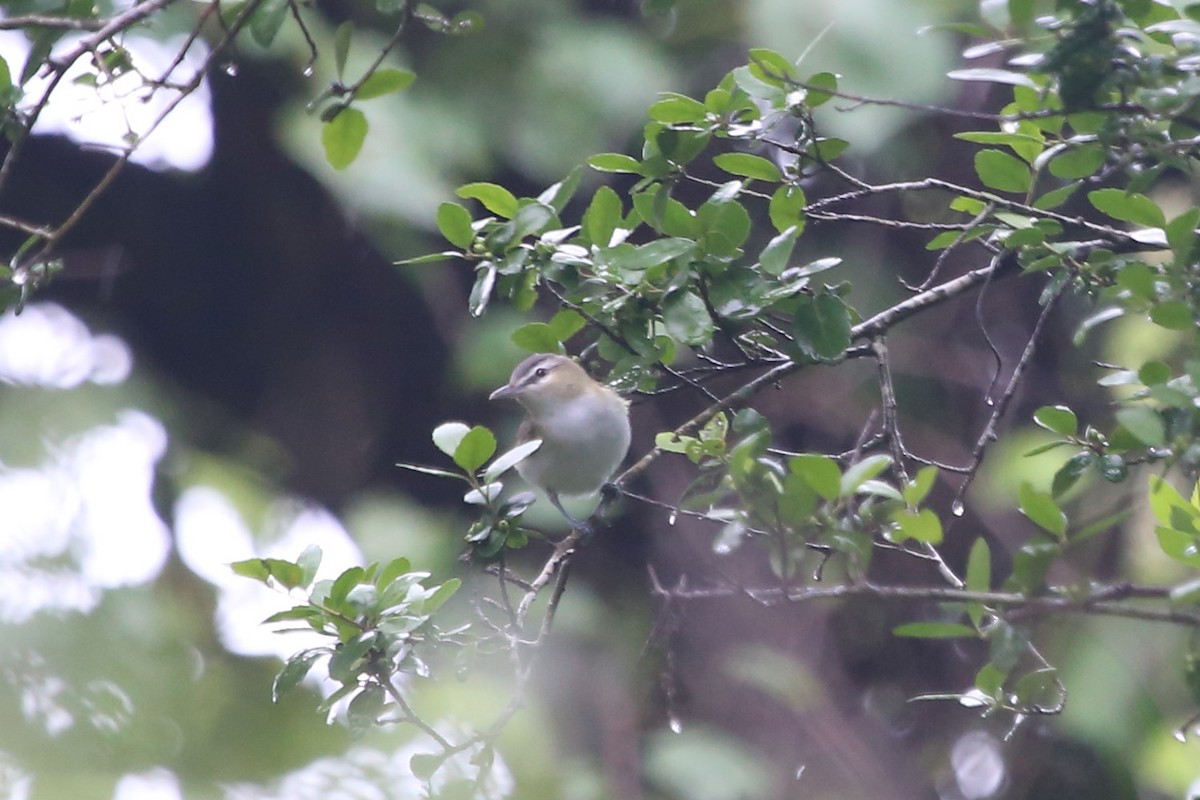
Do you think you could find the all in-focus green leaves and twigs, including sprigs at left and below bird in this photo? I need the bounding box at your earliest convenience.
[7,0,1200,795]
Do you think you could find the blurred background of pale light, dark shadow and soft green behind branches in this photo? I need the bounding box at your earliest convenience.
[0,0,1200,800]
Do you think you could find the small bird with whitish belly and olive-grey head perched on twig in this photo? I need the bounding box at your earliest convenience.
[488,353,629,533]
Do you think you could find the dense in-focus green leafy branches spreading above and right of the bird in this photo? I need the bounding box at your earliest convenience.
[386,1,1200,777]
